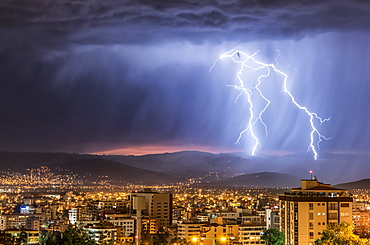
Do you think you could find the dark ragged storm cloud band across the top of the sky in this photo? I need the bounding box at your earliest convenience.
[0,0,370,52]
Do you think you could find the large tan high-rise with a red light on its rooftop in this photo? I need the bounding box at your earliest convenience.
[279,178,352,245]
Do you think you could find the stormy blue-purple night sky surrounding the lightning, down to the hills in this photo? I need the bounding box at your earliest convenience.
[0,0,370,155]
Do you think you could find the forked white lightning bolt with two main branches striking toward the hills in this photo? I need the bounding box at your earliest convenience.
[209,48,330,160]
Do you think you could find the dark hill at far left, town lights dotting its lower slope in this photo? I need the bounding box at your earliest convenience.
[0,152,179,184]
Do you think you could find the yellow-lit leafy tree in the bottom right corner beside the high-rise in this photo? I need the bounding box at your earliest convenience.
[315,222,370,245]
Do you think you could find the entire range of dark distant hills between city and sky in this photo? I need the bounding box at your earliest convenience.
[0,151,370,188]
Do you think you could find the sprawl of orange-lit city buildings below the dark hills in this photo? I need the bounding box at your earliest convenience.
[0,178,370,245]
